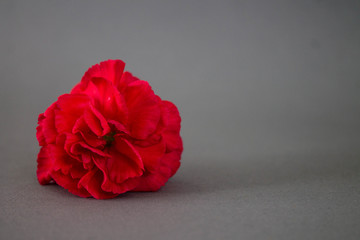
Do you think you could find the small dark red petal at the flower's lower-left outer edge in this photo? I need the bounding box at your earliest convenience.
[36,146,54,185]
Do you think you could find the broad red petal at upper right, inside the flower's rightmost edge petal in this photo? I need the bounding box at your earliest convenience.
[125,81,160,139]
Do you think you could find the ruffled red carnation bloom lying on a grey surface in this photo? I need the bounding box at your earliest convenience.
[36,60,183,199]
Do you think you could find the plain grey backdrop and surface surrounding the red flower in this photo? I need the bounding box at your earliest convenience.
[0,0,360,239]
